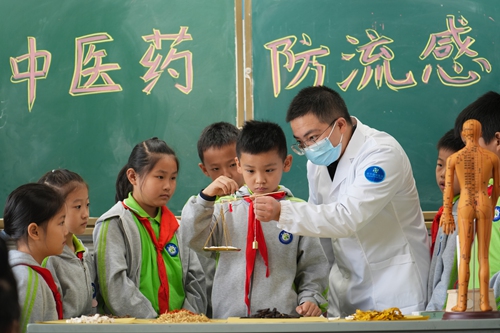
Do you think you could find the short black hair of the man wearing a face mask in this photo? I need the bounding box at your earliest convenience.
[286,86,352,124]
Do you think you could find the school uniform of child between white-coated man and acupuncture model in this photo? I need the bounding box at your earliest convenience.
[426,198,459,311]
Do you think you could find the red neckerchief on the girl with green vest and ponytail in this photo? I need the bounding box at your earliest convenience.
[122,202,179,314]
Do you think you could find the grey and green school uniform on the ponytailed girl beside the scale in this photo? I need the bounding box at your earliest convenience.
[93,195,207,318]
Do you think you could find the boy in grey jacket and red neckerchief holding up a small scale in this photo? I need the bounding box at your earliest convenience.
[181,121,328,318]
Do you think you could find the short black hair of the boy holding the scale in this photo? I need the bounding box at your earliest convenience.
[236,120,287,161]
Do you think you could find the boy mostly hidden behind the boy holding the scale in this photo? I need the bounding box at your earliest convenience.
[190,121,244,318]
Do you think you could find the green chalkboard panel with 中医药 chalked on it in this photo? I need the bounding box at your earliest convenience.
[0,0,236,216]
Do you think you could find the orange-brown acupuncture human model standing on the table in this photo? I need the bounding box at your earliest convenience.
[440,119,500,312]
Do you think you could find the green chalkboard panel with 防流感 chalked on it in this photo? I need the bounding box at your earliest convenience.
[251,0,500,210]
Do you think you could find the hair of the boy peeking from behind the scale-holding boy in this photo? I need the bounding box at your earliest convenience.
[197,121,240,163]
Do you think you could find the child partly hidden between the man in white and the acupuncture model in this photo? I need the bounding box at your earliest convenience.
[426,129,465,311]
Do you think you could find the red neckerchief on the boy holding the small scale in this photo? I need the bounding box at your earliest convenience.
[244,192,286,314]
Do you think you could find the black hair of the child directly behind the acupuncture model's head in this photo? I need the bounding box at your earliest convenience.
[455,91,500,144]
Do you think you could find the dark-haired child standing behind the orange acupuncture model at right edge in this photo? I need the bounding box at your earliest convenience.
[455,91,500,310]
